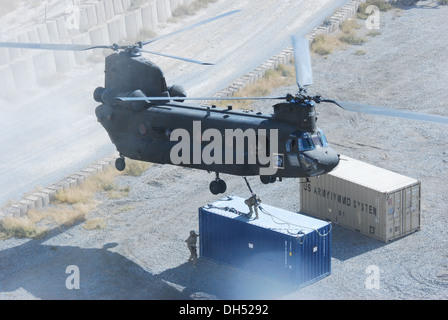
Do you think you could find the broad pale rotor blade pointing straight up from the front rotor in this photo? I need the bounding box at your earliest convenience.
[291,36,313,88]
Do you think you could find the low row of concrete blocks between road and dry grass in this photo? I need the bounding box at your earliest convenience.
[0,0,366,219]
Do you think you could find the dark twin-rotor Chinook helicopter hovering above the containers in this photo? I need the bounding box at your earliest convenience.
[0,11,448,194]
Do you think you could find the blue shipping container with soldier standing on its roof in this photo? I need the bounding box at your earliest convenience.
[199,196,331,287]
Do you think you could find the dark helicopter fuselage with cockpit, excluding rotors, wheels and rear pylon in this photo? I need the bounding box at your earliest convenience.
[96,98,339,179]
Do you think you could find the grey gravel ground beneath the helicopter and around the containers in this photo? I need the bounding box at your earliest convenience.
[0,1,448,299]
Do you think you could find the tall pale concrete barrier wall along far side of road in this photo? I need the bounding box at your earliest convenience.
[0,0,188,100]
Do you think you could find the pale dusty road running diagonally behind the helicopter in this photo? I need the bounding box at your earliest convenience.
[0,0,348,206]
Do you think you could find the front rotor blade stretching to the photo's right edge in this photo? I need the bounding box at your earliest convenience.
[321,100,448,124]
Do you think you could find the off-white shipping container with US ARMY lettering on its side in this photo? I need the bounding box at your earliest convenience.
[300,155,421,242]
